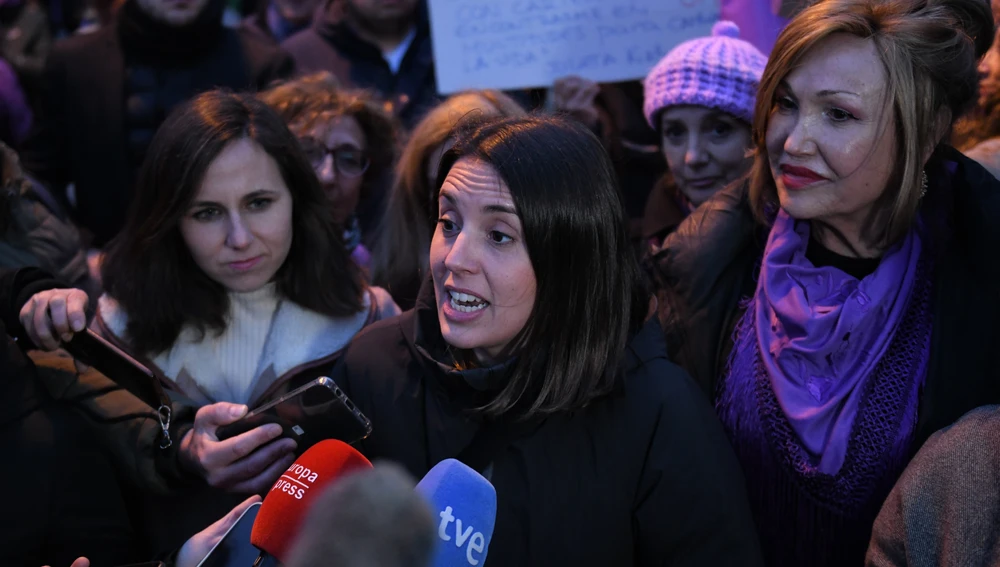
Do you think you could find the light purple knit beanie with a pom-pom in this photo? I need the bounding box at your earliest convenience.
[643,21,767,130]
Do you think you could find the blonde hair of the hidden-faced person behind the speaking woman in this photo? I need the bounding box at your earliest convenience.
[372,90,526,300]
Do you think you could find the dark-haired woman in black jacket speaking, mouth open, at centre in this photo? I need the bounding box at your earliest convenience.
[335,117,760,566]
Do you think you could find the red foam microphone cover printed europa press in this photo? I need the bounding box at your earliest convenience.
[250,439,372,563]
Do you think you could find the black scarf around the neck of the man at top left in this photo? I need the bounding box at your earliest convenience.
[117,0,226,66]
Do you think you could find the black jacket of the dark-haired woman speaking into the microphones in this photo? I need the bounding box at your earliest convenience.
[334,285,760,567]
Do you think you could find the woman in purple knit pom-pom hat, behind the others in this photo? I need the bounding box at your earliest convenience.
[643,21,767,246]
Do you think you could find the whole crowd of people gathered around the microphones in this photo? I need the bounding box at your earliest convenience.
[0,0,1000,567]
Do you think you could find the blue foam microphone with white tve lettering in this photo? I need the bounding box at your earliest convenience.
[416,459,497,567]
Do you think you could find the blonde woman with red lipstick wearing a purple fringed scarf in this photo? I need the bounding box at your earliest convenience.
[655,0,1000,567]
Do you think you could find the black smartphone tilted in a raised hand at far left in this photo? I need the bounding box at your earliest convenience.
[63,328,164,408]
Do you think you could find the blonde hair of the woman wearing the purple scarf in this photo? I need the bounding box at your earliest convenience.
[750,0,994,249]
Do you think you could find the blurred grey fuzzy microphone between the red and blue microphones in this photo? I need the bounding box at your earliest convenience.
[286,463,437,567]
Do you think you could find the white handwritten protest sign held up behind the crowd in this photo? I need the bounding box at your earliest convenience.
[430,0,719,94]
